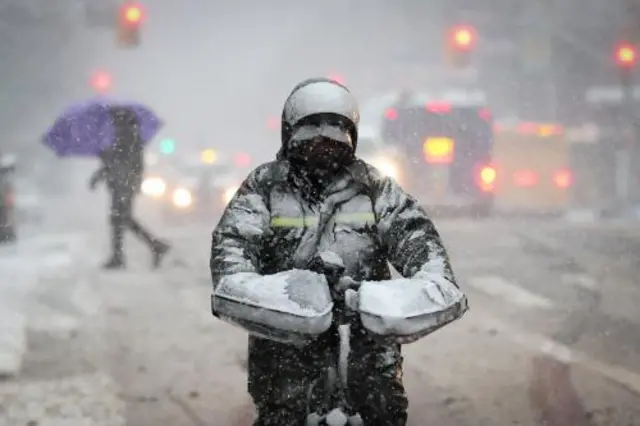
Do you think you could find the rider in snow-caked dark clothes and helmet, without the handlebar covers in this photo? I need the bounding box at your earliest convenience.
[210,79,455,426]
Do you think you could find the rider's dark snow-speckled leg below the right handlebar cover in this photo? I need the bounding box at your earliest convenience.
[349,345,409,426]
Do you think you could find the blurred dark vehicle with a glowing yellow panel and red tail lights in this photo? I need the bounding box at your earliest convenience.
[381,91,497,217]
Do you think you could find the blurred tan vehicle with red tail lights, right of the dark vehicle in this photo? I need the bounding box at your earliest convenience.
[493,121,573,214]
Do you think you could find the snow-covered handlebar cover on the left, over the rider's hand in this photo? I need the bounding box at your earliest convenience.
[211,269,333,344]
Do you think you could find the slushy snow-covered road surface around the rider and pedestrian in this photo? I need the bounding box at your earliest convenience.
[0,208,640,426]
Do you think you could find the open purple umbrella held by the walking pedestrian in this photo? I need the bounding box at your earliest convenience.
[43,98,163,157]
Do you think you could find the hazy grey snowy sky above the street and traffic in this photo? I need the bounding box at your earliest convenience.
[0,0,640,211]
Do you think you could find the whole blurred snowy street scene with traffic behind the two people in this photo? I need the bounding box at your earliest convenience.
[0,0,640,426]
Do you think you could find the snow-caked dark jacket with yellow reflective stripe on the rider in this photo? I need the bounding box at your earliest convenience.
[210,158,456,306]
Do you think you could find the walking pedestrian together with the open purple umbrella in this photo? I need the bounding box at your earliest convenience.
[44,99,170,269]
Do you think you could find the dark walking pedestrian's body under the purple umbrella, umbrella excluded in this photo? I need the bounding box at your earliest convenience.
[90,107,169,269]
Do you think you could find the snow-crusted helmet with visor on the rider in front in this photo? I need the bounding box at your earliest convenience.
[282,78,360,152]
